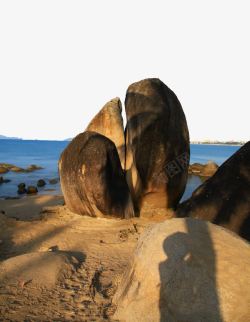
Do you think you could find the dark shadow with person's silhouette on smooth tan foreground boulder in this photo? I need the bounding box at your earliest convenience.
[159,218,223,322]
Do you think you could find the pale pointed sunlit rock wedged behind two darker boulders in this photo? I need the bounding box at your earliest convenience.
[86,97,125,168]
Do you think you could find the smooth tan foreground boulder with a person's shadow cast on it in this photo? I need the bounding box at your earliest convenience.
[113,218,250,322]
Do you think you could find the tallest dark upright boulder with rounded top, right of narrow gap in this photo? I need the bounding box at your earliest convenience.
[125,79,190,213]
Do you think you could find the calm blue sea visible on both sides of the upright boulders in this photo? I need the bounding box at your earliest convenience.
[0,140,239,200]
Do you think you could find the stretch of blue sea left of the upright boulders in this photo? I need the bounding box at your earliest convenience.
[0,140,69,198]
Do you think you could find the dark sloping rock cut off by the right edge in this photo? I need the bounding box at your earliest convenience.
[177,141,250,240]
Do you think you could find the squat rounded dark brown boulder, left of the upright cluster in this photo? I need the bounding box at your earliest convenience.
[59,131,134,218]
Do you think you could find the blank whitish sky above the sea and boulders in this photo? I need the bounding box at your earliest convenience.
[0,0,250,140]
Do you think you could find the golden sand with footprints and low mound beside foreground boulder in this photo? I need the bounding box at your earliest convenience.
[0,196,169,321]
